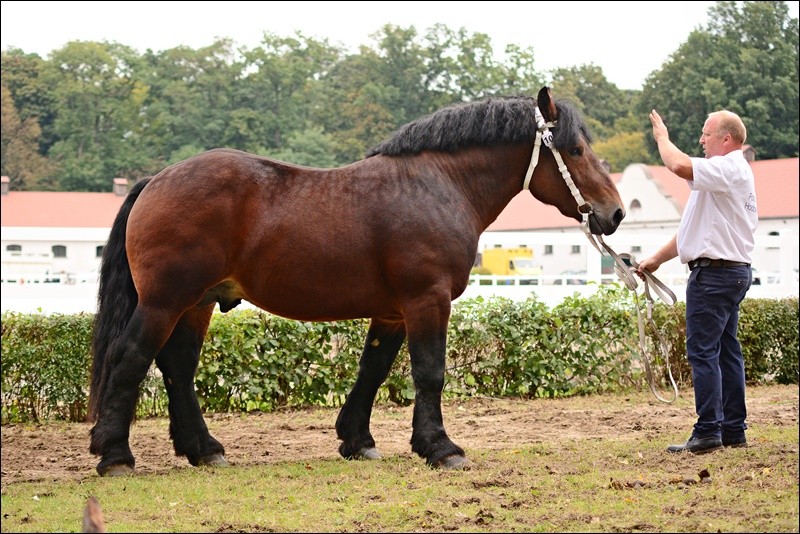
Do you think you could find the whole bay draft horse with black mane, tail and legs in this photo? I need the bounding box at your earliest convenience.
[89,87,625,475]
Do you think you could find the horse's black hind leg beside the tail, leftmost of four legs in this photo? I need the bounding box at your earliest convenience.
[89,304,178,475]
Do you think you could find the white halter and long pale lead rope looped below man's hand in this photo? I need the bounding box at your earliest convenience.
[523,107,678,403]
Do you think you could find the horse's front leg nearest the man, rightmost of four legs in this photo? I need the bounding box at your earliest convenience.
[405,297,468,469]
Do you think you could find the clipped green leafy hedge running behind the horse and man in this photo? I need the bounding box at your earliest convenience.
[2,284,798,422]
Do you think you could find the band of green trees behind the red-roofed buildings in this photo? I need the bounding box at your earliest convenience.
[0,1,800,191]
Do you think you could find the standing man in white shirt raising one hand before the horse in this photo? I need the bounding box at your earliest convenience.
[639,110,758,454]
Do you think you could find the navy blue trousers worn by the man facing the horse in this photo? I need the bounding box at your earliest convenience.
[686,265,753,438]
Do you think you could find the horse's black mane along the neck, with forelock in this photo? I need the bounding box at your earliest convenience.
[367,96,591,157]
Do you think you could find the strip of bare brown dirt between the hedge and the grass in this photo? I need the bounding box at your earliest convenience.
[1,385,798,488]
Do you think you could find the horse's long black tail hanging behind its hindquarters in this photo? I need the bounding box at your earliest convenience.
[89,178,150,421]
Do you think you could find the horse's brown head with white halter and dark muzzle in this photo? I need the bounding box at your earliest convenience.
[526,87,625,235]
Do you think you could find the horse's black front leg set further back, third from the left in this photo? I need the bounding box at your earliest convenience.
[336,319,406,458]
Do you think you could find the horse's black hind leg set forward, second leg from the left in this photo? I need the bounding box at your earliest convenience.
[156,304,228,466]
